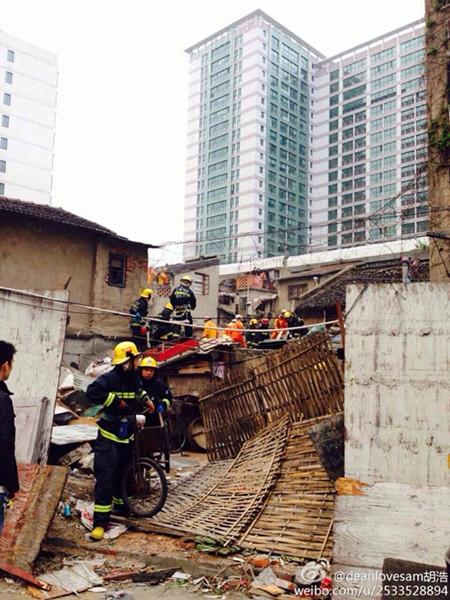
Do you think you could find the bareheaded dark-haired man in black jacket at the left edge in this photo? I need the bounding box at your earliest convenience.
[0,341,19,531]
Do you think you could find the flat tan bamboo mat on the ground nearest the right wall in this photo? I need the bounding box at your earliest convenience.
[237,418,334,559]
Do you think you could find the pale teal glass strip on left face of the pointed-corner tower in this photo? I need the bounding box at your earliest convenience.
[195,31,242,260]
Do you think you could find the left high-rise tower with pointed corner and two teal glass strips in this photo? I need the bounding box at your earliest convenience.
[184,10,323,262]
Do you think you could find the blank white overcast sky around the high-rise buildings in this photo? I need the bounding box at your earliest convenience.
[0,0,424,258]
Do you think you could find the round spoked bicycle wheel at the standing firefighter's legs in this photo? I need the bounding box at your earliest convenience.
[122,458,167,517]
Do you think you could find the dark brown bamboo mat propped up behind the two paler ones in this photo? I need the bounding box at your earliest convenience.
[200,333,344,461]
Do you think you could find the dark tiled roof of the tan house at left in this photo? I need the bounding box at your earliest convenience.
[0,196,155,246]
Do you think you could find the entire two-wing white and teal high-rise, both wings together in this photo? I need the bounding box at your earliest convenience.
[184,10,427,262]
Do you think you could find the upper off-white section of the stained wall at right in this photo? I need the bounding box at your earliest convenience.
[345,283,450,486]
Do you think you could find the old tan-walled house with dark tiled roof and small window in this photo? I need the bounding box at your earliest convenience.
[0,197,151,366]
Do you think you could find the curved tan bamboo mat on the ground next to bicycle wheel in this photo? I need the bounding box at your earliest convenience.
[152,418,288,545]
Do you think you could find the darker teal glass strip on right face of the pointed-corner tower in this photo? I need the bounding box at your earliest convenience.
[265,28,310,256]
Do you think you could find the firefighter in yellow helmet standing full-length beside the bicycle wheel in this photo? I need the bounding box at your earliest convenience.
[87,342,154,541]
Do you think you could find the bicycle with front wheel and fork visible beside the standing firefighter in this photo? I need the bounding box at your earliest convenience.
[121,410,168,517]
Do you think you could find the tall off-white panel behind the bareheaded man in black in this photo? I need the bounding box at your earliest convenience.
[0,287,69,464]
